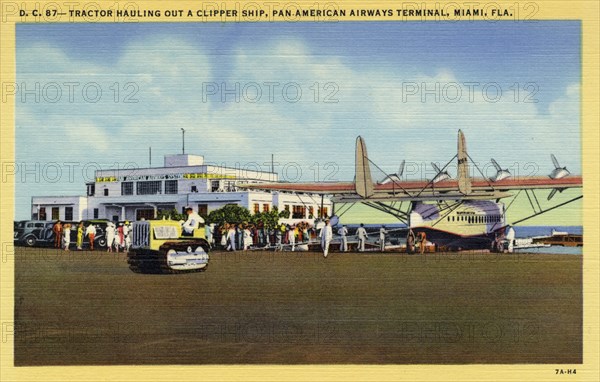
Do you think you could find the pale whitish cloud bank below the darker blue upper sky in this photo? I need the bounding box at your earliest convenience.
[17,37,581,218]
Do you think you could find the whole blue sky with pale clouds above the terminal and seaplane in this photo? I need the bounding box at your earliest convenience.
[16,21,581,218]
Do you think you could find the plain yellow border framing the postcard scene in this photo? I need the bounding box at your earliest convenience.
[0,0,600,381]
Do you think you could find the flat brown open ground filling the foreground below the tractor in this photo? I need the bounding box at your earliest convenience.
[14,248,582,366]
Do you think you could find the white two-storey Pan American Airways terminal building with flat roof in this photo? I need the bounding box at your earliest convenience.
[31,154,333,221]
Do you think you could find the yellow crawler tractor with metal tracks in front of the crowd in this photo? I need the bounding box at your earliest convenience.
[127,220,210,274]
